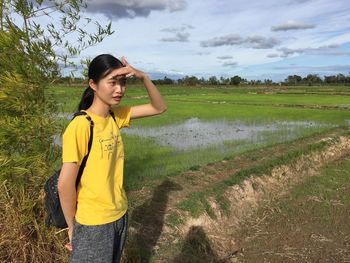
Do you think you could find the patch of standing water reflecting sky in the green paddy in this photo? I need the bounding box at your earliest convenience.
[123,118,334,150]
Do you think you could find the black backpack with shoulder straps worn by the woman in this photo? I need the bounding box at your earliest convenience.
[44,111,116,228]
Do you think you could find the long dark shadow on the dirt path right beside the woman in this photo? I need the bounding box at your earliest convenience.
[125,180,182,263]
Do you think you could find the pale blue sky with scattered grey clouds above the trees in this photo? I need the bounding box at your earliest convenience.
[66,0,350,81]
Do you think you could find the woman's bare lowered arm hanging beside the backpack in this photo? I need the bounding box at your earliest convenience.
[57,163,79,248]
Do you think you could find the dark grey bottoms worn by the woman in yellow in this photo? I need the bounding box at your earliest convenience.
[69,213,128,263]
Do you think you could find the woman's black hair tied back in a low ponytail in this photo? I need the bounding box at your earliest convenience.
[78,54,124,111]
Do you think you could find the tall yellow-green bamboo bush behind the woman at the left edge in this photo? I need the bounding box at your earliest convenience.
[0,0,111,262]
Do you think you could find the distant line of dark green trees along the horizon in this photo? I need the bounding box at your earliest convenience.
[56,74,350,86]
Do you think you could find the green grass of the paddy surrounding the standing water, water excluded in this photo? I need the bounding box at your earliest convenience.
[48,86,350,190]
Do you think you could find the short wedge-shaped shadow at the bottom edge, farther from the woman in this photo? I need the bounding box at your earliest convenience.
[173,226,225,263]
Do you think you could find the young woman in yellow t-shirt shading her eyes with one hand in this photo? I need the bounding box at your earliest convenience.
[58,54,166,263]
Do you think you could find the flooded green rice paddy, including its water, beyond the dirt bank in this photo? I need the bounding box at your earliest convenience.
[48,85,350,191]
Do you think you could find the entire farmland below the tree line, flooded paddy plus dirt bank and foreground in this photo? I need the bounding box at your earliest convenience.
[47,85,350,263]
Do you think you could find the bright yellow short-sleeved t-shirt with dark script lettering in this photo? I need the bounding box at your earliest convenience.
[62,106,131,225]
